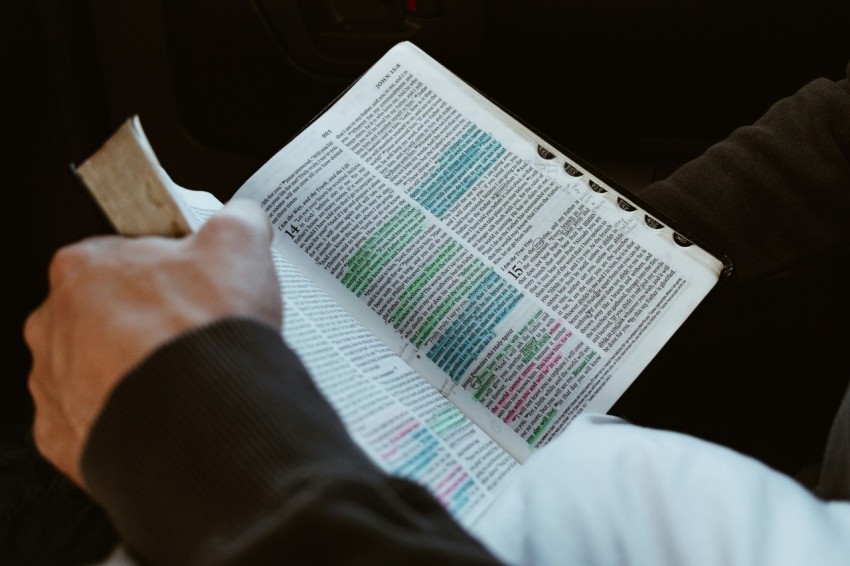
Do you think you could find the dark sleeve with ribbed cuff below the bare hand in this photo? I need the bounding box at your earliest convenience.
[82,320,495,565]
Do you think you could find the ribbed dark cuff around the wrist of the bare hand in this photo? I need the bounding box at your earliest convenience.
[82,319,381,564]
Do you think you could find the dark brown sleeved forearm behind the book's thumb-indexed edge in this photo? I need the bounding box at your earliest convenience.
[642,63,850,282]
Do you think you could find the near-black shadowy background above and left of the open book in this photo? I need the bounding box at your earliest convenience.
[6,0,850,564]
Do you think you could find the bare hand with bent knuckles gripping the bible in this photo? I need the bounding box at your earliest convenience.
[24,201,282,486]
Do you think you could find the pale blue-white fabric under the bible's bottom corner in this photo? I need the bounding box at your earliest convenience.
[473,415,850,566]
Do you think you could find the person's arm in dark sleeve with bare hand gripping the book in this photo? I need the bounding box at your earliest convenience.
[25,204,495,564]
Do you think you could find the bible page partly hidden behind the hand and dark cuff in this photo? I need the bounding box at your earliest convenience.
[179,189,518,527]
